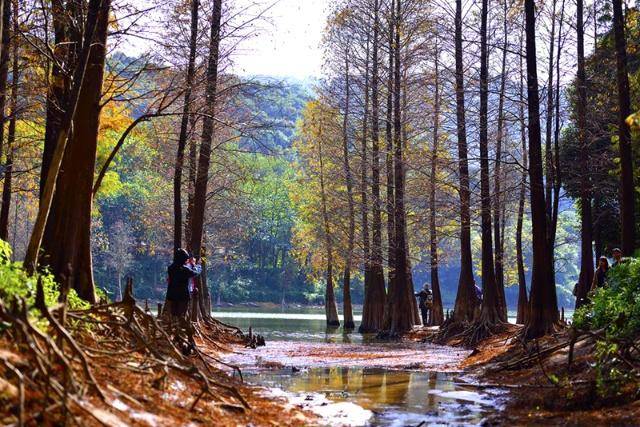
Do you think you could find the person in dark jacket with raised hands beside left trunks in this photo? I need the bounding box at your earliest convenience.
[167,249,202,318]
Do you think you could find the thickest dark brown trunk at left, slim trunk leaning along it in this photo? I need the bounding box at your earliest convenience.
[25,0,110,302]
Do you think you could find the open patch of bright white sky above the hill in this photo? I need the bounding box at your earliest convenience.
[234,0,331,79]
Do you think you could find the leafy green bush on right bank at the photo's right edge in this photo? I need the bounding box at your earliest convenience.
[573,258,640,396]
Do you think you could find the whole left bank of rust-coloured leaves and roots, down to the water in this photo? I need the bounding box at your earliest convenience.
[0,290,315,427]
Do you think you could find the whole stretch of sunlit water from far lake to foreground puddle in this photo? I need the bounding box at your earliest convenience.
[214,308,503,426]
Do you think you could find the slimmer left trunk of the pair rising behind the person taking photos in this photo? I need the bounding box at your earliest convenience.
[173,0,200,251]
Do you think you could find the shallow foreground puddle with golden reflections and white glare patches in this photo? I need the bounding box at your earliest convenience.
[244,367,502,426]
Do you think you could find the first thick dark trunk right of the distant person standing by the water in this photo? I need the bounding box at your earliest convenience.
[453,0,479,322]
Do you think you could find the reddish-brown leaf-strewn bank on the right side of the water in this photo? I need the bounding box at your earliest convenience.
[410,325,640,426]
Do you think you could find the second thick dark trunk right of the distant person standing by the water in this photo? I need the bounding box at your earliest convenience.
[480,0,502,323]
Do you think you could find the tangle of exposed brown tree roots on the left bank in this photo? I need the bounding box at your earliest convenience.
[0,280,276,425]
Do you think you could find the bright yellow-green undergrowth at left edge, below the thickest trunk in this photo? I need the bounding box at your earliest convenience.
[0,240,89,328]
